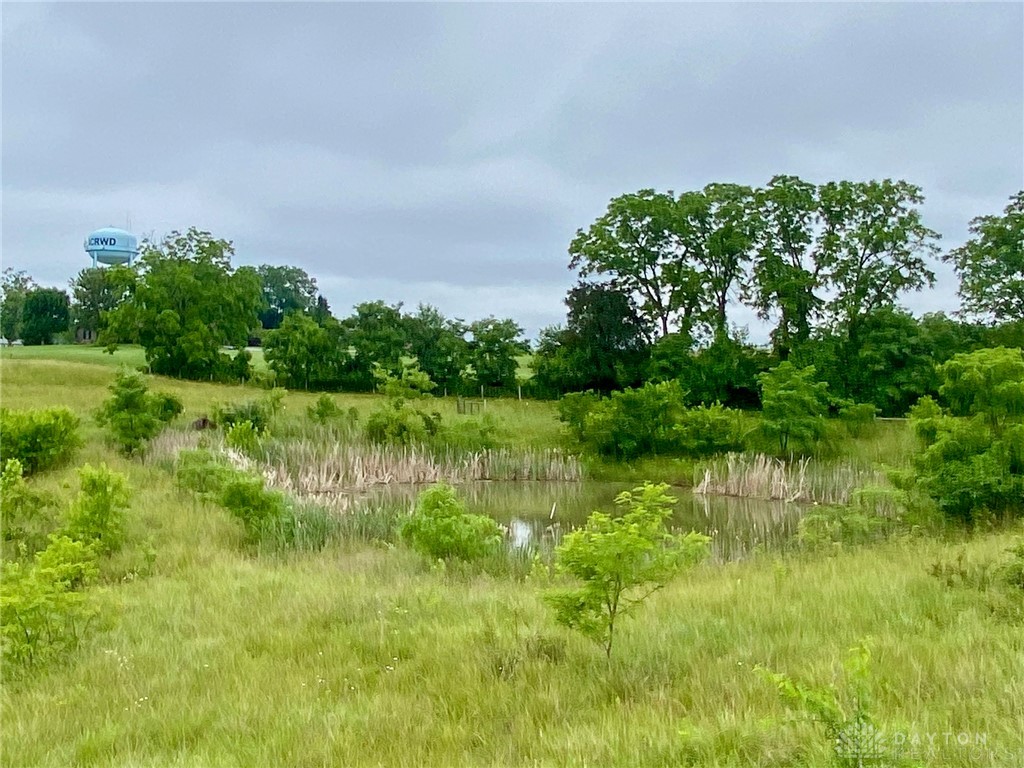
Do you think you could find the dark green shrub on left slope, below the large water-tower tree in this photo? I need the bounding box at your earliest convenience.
[96,369,182,456]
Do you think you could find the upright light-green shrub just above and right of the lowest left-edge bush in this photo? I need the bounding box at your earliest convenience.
[66,464,131,552]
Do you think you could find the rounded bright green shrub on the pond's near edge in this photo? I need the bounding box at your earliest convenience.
[400,483,502,561]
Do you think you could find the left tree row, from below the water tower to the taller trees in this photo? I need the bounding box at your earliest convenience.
[0,228,529,393]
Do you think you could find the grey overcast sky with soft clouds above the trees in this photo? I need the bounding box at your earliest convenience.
[2,2,1024,339]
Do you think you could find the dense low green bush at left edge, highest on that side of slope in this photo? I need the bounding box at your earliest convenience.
[0,408,82,475]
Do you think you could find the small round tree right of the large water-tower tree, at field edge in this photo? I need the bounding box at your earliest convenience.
[263,313,350,390]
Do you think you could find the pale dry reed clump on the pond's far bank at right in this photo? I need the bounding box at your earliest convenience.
[693,454,886,505]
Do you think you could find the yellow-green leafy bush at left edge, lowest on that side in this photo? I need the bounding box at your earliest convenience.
[0,536,98,677]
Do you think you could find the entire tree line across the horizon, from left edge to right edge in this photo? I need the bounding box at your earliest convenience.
[0,182,1024,415]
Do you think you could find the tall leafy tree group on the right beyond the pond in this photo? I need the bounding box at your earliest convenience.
[534,176,1024,416]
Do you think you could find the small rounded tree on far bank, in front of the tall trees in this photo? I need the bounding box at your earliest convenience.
[758,360,828,456]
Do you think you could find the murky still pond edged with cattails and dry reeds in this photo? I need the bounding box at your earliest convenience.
[362,480,805,562]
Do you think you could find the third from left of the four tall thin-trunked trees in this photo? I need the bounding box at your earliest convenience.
[748,176,823,360]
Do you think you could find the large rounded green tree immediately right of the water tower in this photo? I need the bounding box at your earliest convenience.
[100,227,261,379]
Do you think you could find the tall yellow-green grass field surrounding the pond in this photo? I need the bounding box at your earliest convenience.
[0,358,1024,768]
